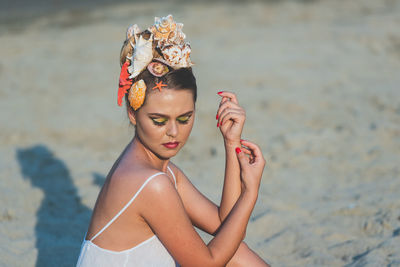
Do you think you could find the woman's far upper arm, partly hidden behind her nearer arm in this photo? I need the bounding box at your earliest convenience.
[173,166,221,234]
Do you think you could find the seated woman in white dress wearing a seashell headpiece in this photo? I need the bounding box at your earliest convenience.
[77,15,268,266]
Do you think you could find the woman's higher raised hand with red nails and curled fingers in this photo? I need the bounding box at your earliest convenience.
[217,91,246,147]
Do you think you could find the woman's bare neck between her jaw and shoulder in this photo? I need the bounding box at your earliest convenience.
[129,136,169,172]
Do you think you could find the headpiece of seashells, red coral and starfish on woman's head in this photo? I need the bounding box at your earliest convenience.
[118,15,193,110]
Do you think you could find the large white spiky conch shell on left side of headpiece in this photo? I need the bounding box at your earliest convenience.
[127,34,153,79]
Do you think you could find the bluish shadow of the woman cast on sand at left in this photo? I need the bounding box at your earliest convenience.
[16,145,93,267]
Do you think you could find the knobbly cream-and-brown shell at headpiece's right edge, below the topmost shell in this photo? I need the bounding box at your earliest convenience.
[161,43,193,68]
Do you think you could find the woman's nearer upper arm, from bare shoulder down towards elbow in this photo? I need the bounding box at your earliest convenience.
[141,175,216,266]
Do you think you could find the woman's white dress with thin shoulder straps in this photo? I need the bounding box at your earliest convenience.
[76,167,179,267]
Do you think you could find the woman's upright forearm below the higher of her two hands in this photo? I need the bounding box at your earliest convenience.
[219,140,241,222]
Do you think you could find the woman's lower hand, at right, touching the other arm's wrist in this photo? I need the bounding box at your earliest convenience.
[236,140,265,195]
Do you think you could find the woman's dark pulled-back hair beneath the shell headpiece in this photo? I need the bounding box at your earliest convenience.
[125,68,197,112]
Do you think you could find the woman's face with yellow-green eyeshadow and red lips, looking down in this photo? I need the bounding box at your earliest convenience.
[130,89,195,159]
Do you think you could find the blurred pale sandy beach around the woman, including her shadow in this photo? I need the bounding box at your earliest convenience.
[0,0,400,266]
